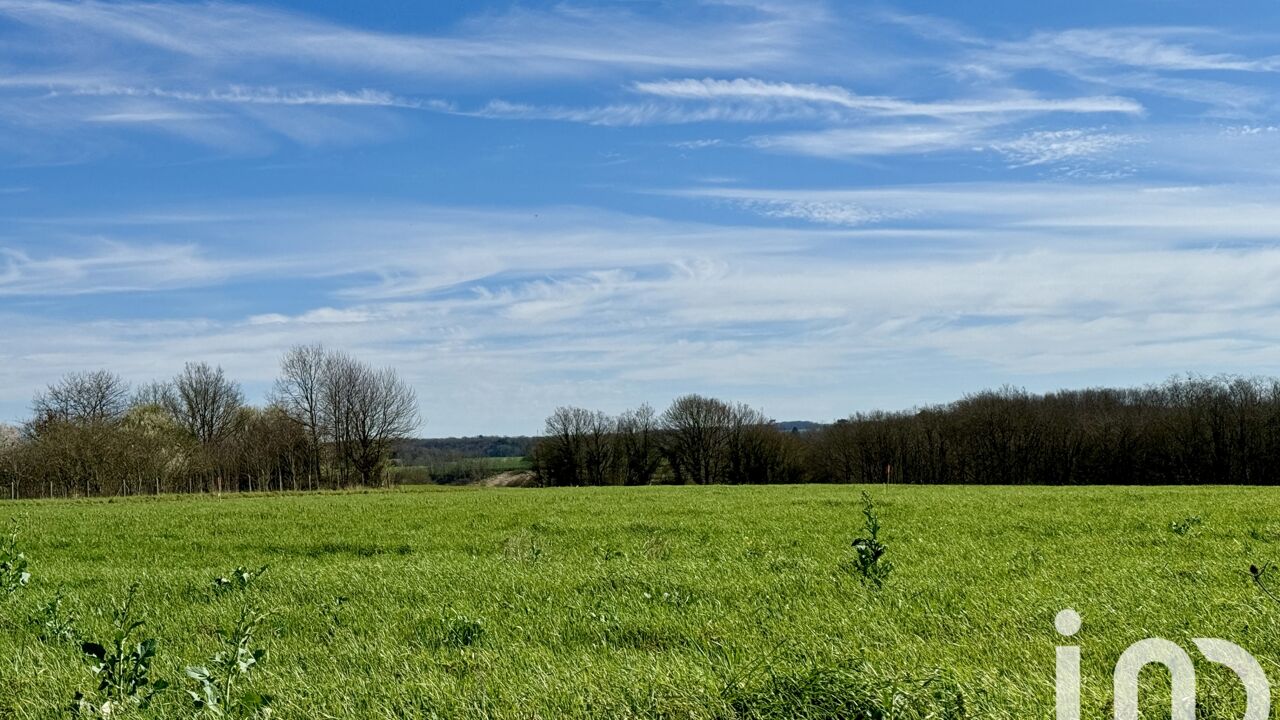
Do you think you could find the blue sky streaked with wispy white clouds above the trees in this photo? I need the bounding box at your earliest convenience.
[0,0,1280,437]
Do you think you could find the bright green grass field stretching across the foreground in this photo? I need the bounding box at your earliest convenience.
[0,486,1280,719]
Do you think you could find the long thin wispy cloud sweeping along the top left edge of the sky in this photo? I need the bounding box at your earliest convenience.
[0,0,823,78]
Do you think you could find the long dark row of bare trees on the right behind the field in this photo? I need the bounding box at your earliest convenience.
[532,377,1280,486]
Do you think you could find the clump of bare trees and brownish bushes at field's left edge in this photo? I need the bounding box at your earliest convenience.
[0,345,419,498]
